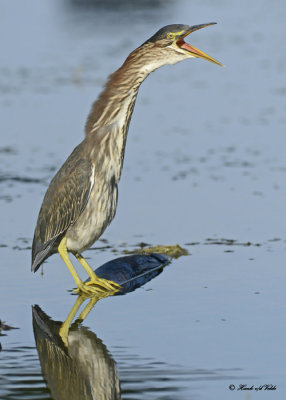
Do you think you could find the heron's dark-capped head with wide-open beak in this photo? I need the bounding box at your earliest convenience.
[131,22,222,72]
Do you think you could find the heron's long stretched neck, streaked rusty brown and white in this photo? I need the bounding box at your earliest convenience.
[86,50,157,182]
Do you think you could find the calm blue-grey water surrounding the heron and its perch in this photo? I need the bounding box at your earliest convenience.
[0,0,286,400]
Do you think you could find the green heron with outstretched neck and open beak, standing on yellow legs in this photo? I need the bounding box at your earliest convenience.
[32,22,222,294]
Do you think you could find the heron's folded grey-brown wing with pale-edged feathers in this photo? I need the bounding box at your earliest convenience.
[32,148,93,271]
